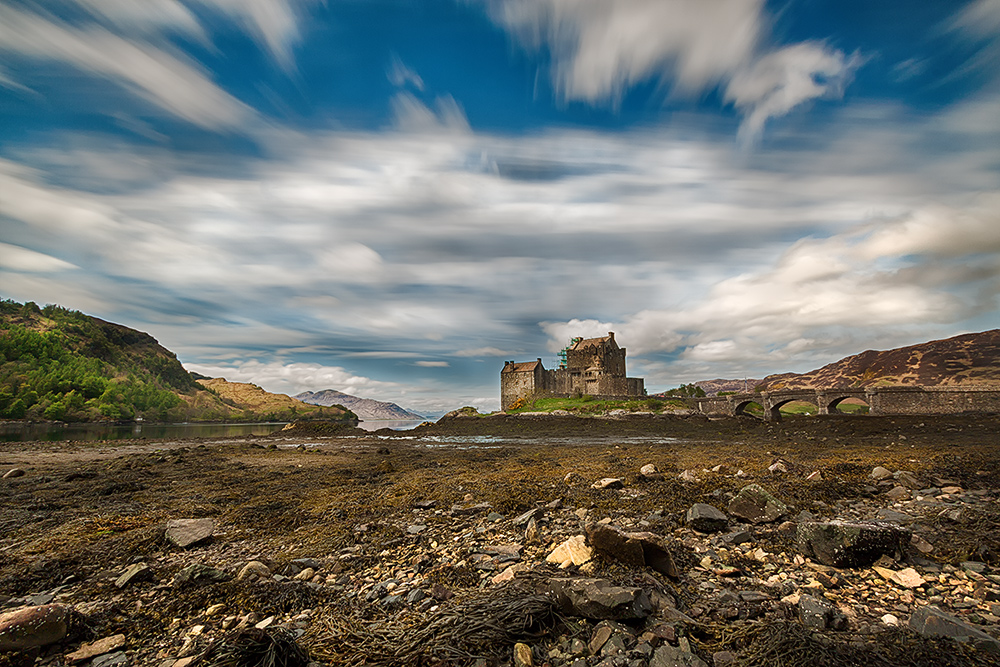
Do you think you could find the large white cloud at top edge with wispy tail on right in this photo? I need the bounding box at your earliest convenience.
[480,0,860,141]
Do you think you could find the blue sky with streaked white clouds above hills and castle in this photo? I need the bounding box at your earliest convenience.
[0,0,1000,414]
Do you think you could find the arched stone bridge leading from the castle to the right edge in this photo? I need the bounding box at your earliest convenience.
[693,387,1000,421]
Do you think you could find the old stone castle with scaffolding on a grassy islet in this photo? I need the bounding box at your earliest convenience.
[500,332,646,410]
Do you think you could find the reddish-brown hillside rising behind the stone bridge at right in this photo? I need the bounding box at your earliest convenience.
[758,329,1000,391]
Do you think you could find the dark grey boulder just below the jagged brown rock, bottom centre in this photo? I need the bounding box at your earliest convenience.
[548,579,653,621]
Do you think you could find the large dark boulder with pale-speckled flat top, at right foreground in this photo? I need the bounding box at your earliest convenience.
[796,521,910,567]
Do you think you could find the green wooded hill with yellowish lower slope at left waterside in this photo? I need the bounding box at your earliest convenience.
[0,300,354,421]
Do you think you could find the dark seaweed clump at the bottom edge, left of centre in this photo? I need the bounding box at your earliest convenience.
[194,628,309,667]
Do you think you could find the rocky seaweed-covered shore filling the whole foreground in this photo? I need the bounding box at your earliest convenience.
[0,416,1000,667]
